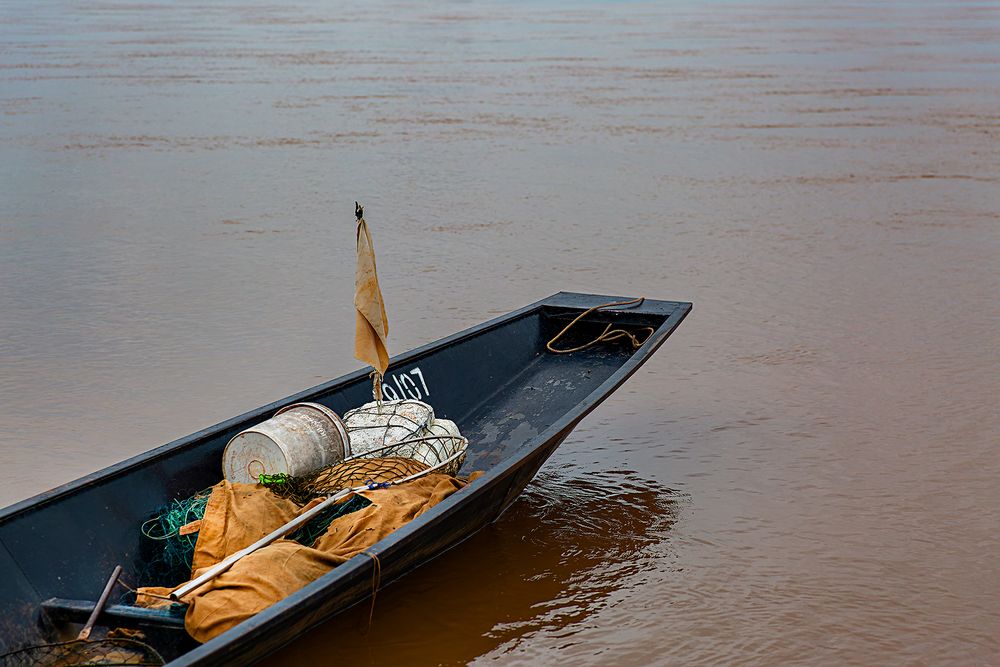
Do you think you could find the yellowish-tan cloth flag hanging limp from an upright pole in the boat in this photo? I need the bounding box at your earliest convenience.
[354,202,389,376]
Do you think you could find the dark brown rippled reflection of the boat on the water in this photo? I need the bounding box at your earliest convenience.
[269,465,684,665]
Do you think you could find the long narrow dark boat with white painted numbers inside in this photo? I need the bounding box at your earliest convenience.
[0,293,691,665]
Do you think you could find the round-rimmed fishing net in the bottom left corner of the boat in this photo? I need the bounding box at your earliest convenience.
[0,637,164,667]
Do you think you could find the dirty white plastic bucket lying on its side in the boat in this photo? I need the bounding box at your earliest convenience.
[222,403,348,483]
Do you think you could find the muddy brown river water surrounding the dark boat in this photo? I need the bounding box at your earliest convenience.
[0,0,1000,665]
